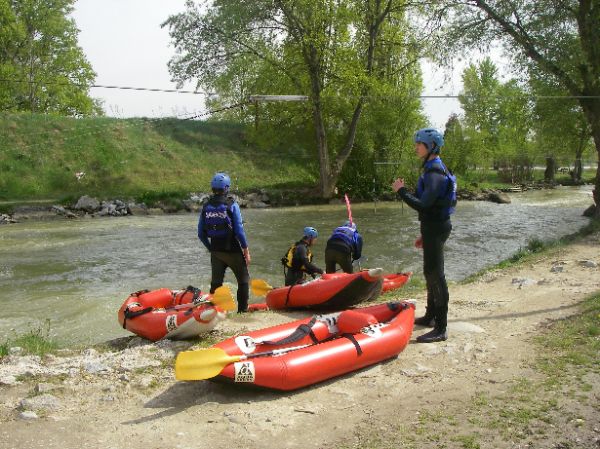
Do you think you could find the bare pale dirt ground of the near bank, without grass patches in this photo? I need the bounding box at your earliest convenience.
[0,234,600,449]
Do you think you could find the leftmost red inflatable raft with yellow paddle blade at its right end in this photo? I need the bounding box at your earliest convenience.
[118,287,235,341]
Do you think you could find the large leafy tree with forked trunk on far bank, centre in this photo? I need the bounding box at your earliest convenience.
[164,0,421,198]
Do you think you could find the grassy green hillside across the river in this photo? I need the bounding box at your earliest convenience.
[0,114,317,201]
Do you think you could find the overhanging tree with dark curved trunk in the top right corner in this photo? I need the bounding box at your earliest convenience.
[443,0,600,217]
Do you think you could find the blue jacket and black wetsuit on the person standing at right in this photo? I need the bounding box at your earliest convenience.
[398,157,452,333]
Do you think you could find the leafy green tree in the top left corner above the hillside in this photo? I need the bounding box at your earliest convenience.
[0,0,102,116]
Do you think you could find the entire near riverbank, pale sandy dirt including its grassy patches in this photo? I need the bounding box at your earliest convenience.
[0,230,600,449]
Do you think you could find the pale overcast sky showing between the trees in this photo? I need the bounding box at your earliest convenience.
[73,0,486,128]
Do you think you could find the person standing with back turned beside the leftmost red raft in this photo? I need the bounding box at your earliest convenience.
[198,173,250,313]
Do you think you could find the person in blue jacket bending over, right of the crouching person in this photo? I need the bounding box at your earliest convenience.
[325,221,362,273]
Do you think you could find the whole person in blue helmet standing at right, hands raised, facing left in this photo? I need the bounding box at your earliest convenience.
[392,128,456,343]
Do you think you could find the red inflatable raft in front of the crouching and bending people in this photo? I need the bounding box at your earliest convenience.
[266,268,383,310]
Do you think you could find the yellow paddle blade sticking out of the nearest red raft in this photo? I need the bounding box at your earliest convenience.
[175,348,244,380]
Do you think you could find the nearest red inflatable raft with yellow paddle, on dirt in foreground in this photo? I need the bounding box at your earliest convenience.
[175,302,415,390]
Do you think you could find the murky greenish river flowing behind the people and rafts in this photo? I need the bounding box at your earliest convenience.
[0,187,592,344]
